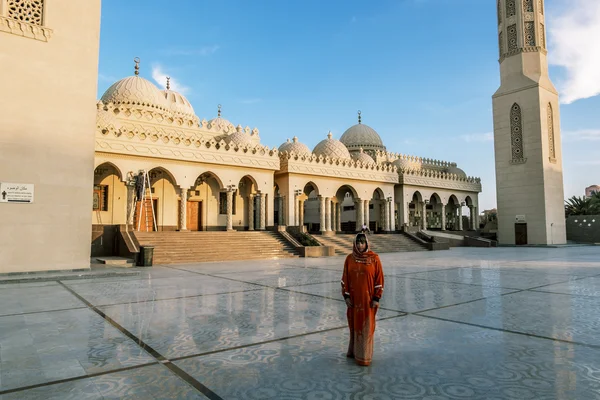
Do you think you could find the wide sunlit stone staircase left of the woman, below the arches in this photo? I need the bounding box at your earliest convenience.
[134,231,298,265]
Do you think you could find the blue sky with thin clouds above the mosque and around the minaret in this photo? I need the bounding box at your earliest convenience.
[98,0,600,210]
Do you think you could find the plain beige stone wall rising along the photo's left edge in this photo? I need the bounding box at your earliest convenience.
[0,0,100,273]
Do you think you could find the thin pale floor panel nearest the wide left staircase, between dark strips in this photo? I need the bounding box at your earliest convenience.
[65,274,261,305]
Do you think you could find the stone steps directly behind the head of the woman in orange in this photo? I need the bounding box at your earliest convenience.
[315,233,427,255]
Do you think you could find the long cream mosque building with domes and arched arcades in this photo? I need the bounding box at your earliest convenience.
[92,59,481,235]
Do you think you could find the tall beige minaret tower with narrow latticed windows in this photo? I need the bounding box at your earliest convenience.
[493,0,566,245]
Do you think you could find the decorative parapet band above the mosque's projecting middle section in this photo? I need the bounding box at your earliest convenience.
[279,151,398,183]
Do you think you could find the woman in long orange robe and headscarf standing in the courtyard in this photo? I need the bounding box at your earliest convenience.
[342,233,383,366]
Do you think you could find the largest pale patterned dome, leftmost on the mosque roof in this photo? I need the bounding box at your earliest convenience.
[102,75,168,110]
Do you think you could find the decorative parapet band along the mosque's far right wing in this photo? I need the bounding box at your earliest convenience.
[398,169,481,193]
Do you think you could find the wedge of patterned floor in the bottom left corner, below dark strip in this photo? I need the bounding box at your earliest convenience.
[1,365,206,400]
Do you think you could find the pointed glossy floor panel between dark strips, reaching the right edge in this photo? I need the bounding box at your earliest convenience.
[423,292,600,346]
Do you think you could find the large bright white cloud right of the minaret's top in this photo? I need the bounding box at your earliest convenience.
[547,0,600,104]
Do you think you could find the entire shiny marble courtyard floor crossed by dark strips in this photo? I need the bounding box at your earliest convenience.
[0,247,600,400]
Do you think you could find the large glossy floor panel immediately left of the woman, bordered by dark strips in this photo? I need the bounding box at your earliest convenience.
[101,289,398,358]
